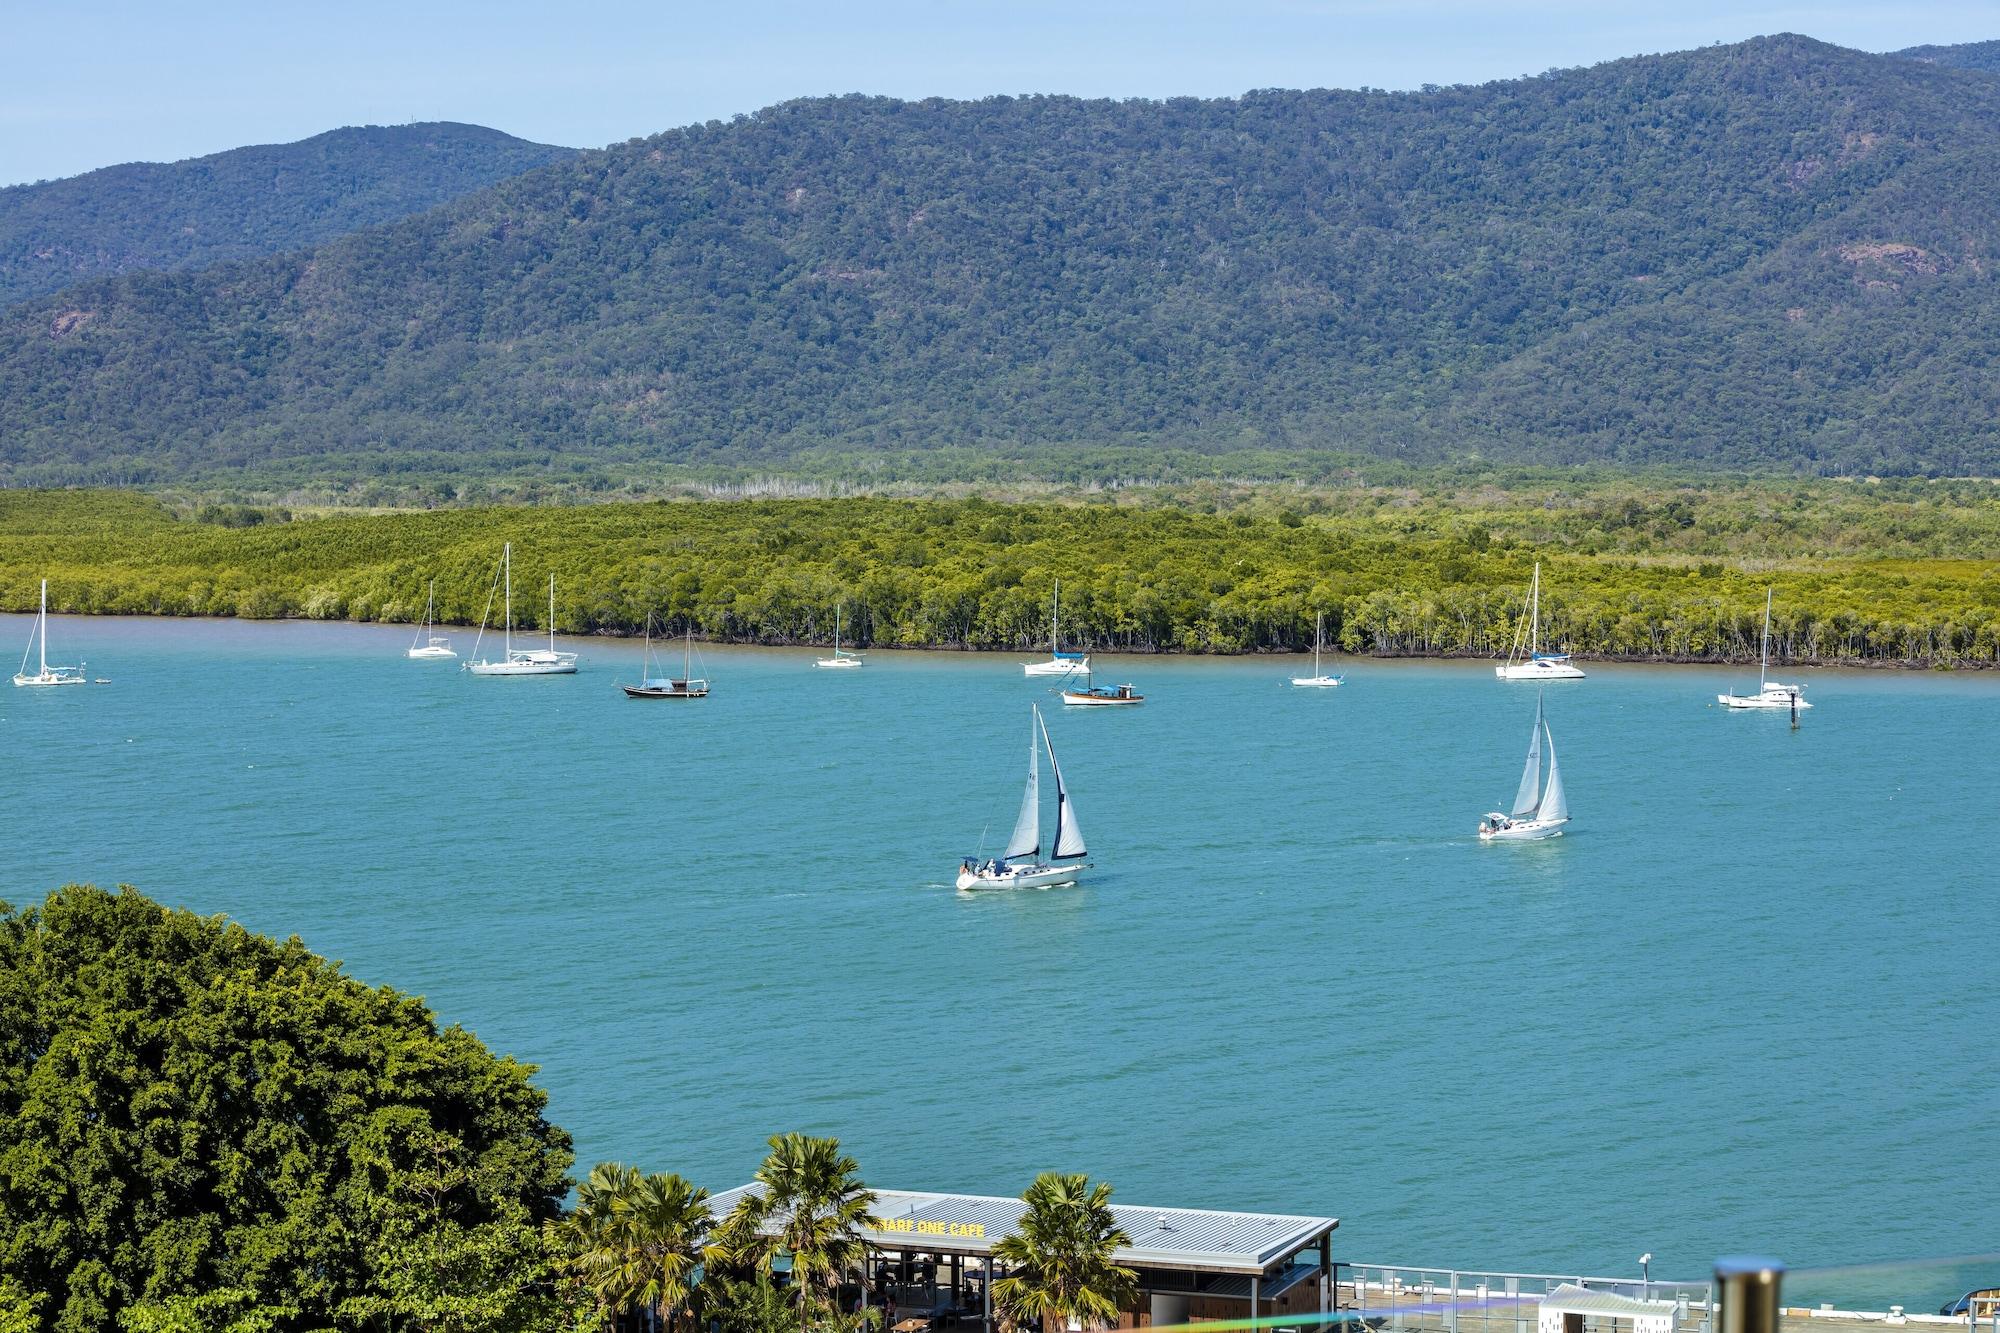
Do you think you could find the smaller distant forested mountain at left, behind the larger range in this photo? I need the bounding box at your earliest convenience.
[0,122,574,306]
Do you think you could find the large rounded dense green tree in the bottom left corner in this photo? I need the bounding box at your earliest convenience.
[0,887,572,1333]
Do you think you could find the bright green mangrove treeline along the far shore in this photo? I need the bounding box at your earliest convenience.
[0,482,2000,667]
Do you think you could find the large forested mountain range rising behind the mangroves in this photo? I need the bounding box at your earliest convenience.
[11,36,2000,484]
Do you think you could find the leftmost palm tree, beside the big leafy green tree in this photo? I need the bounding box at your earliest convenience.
[560,1163,714,1329]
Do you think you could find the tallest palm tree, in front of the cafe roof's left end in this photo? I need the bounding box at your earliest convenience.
[722,1135,880,1327]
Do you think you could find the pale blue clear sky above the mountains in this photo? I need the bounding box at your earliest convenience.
[11,0,2000,184]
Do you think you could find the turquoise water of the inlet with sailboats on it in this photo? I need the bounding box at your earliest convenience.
[0,618,2000,1307]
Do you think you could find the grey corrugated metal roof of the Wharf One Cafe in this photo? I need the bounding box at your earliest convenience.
[710,1185,1340,1273]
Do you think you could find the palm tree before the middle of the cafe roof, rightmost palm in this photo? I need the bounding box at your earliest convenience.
[994,1171,1138,1333]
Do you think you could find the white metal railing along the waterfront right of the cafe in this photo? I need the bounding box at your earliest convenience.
[1334,1263,1714,1333]
